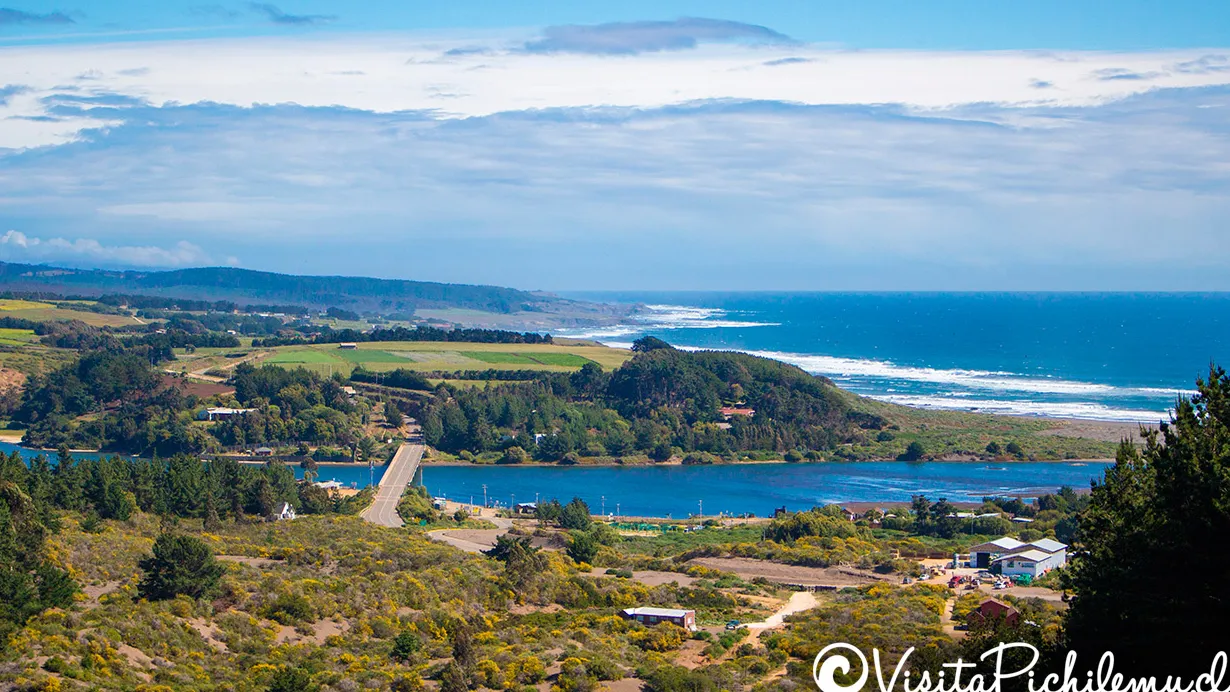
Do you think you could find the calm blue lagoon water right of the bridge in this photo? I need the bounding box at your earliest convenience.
[423,461,1108,517]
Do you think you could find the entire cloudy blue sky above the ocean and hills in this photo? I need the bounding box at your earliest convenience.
[0,0,1230,291]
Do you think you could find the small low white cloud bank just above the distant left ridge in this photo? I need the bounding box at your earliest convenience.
[0,230,216,267]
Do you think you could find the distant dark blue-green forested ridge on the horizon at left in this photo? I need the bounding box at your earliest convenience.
[0,262,615,313]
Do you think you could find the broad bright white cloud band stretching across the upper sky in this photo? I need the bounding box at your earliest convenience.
[0,33,1230,146]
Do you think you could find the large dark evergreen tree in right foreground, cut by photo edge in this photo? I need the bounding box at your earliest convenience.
[1065,366,1230,680]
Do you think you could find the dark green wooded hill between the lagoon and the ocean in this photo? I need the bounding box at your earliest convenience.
[417,348,884,461]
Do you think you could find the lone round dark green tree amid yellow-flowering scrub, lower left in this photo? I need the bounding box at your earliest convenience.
[138,533,226,601]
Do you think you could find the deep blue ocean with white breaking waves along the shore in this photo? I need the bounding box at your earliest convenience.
[557,293,1230,422]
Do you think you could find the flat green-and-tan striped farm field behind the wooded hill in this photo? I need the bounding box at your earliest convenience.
[253,342,631,374]
